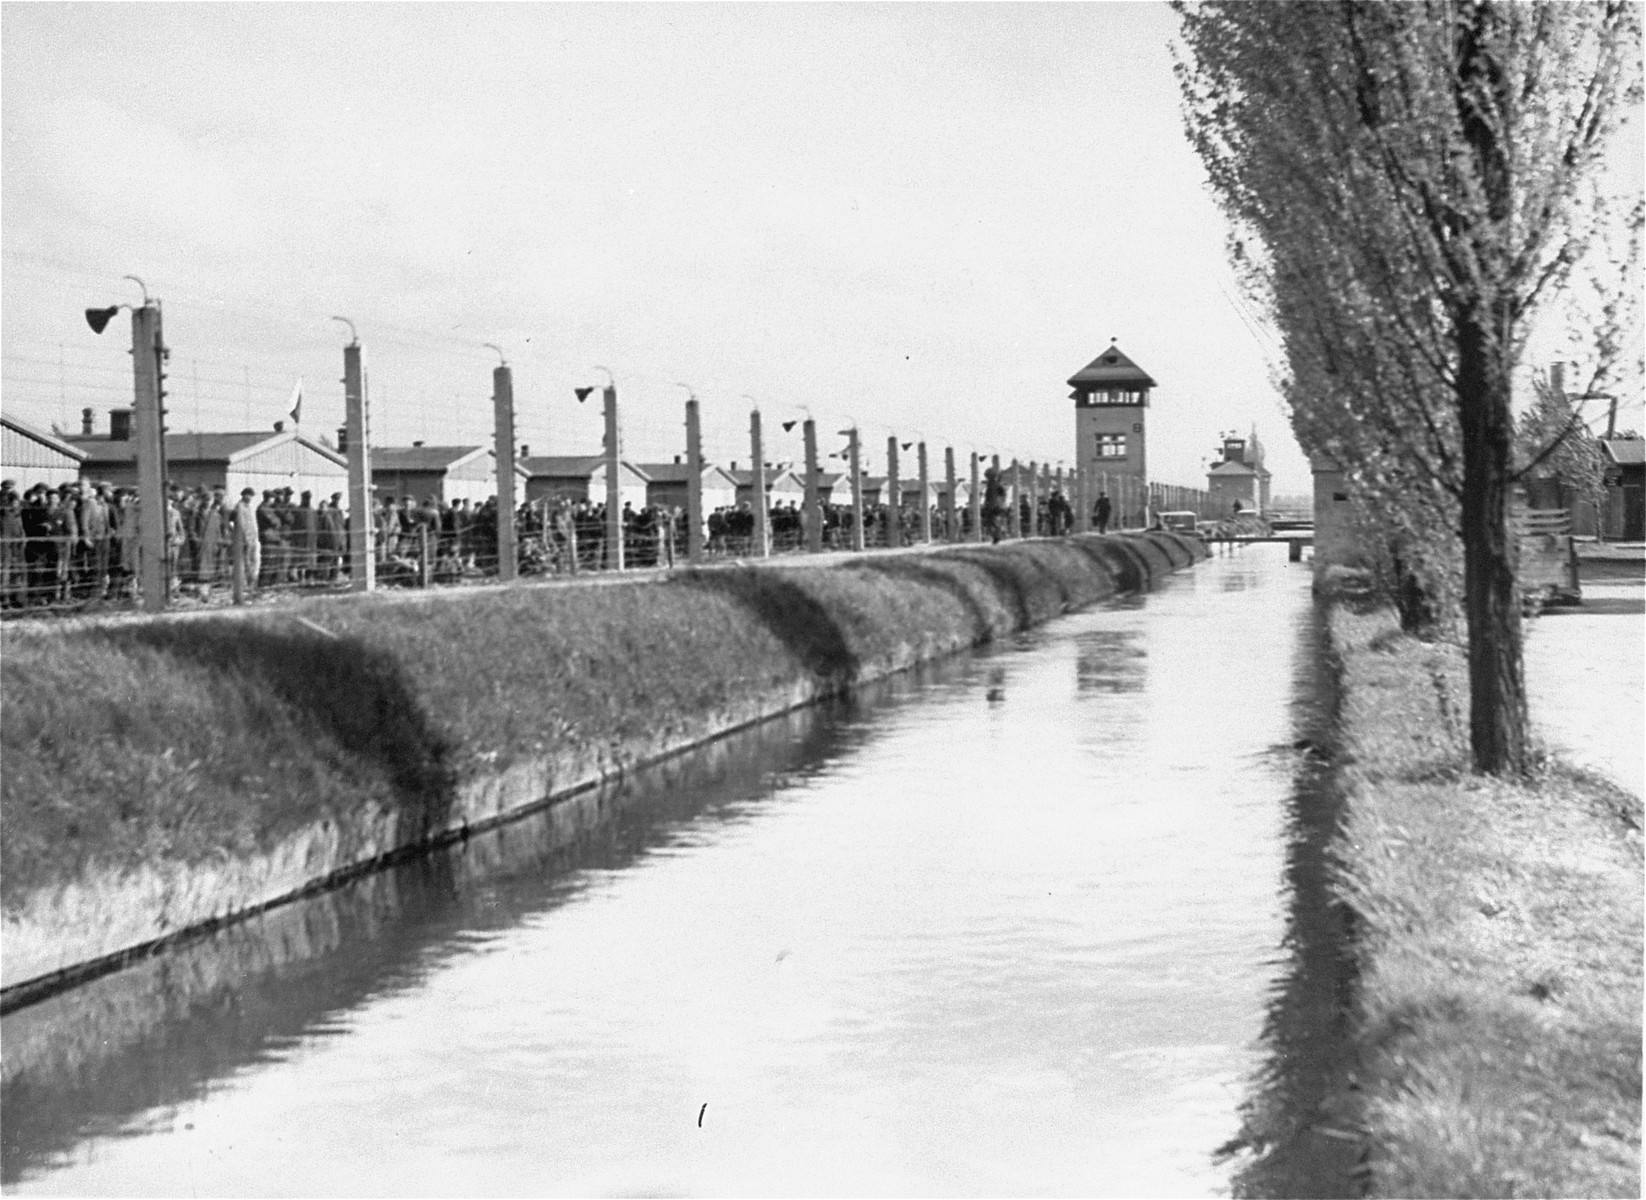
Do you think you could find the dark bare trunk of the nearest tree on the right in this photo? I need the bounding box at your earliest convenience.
[1455,314,1526,775]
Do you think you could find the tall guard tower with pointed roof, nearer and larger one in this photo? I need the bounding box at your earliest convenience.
[1068,341,1154,528]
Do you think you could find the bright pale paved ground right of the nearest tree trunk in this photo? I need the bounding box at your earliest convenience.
[1526,579,1646,797]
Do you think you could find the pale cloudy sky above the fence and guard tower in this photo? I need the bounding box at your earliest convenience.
[0,3,1639,492]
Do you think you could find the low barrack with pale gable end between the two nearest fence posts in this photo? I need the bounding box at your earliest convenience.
[64,408,349,507]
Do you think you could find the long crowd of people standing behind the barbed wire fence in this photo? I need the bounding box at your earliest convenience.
[0,472,1109,607]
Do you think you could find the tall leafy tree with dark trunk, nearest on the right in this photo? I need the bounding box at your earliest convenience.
[1179,0,1641,774]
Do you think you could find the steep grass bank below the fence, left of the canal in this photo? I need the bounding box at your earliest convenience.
[0,533,1205,1004]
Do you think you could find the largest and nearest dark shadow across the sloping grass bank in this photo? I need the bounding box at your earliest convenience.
[104,621,454,838]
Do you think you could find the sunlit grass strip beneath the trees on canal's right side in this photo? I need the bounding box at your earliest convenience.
[1332,609,1641,1197]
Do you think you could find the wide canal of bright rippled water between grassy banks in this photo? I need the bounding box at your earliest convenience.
[0,547,1336,1195]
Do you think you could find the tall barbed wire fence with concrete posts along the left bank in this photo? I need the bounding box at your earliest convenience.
[0,252,1210,616]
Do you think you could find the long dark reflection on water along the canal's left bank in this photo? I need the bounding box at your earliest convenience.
[0,678,915,1184]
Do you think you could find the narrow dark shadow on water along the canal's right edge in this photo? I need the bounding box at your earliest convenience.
[1220,602,1365,1197]
